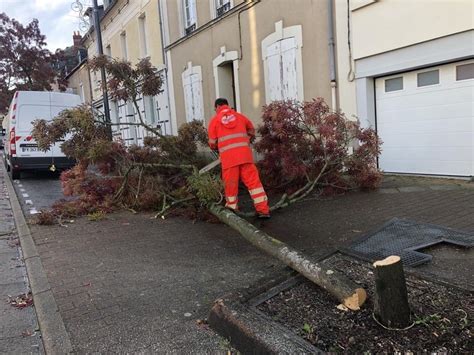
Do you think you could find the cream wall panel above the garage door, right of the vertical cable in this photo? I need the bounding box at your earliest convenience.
[352,0,474,59]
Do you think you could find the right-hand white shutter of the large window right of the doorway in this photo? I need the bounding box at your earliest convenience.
[280,37,298,100]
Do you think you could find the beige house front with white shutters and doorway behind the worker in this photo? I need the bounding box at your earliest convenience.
[160,0,332,132]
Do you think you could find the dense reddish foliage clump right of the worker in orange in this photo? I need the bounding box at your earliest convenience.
[256,99,381,193]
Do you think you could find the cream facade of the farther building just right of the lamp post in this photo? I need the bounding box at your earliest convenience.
[83,0,172,145]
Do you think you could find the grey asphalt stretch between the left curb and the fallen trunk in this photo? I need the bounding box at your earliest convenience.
[32,212,276,352]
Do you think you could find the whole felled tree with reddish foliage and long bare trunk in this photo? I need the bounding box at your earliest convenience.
[33,57,380,310]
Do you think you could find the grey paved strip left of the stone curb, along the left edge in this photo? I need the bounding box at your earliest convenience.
[0,169,44,354]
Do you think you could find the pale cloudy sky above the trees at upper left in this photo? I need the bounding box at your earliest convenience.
[0,0,102,52]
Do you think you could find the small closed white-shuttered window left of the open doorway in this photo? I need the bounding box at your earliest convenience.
[182,63,204,122]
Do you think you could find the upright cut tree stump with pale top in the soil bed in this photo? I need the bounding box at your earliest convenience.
[373,255,411,329]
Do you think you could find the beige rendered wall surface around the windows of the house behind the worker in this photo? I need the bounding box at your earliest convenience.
[166,0,331,126]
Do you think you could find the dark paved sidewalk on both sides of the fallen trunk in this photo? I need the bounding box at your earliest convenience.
[15,178,474,353]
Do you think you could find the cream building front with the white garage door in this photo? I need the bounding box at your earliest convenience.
[335,0,474,176]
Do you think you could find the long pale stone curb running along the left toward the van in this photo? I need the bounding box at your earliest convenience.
[1,164,73,354]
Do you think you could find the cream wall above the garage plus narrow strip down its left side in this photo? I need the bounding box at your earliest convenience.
[334,0,474,117]
